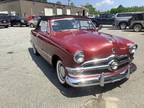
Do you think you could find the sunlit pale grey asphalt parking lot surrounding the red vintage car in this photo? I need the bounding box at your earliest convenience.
[0,27,144,108]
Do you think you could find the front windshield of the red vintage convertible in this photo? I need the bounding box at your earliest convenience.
[52,18,95,31]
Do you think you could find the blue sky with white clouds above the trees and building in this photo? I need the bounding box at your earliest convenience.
[48,0,144,11]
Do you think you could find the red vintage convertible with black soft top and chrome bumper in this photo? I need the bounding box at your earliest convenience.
[31,15,137,87]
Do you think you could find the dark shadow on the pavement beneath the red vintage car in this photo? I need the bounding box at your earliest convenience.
[28,48,137,98]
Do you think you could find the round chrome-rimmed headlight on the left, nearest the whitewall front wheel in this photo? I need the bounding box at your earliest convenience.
[74,51,84,63]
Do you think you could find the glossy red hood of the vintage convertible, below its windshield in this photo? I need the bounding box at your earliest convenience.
[54,30,131,59]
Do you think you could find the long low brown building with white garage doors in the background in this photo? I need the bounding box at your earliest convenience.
[0,0,88,16]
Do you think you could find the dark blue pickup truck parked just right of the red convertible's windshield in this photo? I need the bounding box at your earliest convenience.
[92,14,114,26]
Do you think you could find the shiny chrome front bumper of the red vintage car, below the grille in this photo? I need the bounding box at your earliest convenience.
[66,64,131,87]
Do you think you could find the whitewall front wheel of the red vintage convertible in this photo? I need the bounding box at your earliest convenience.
[56,60,68,87]
